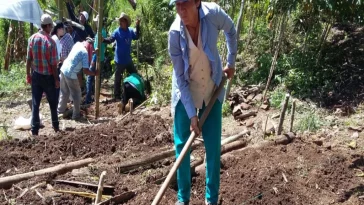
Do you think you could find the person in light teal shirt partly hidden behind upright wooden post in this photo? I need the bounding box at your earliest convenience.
[85,15,107,104]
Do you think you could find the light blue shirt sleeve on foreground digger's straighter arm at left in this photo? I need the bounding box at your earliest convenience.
[168,30,197,119]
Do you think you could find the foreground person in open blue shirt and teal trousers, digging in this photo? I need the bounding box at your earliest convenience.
[168,0,237,205]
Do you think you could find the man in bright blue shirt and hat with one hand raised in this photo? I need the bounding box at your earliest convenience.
[103,13,140,100]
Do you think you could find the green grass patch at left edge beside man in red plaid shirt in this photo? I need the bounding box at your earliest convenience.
[0,63,30,97]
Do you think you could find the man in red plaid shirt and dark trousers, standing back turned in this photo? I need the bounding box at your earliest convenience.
[26,14,59,135]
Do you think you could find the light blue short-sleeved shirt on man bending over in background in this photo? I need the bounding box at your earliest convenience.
[61,42,89,79]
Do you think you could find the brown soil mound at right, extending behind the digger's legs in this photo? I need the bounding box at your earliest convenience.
[128,142,364,205]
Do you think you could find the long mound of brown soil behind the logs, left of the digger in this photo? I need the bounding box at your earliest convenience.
[0,115,172,175]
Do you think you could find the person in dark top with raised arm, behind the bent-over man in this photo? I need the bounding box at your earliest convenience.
[65,0,95,43]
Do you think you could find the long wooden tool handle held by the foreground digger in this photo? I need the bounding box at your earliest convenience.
[152,75,227,205]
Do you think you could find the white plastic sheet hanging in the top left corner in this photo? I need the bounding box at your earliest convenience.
[0,0,43,28]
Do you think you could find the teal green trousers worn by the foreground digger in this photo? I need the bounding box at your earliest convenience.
[173,100,222,203]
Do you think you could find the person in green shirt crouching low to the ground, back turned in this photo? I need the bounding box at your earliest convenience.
[118,73,146,114]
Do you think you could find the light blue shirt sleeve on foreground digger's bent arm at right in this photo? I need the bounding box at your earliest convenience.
[216,4,238,67]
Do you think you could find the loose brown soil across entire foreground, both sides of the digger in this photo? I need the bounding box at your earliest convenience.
[0,116,364,205]
